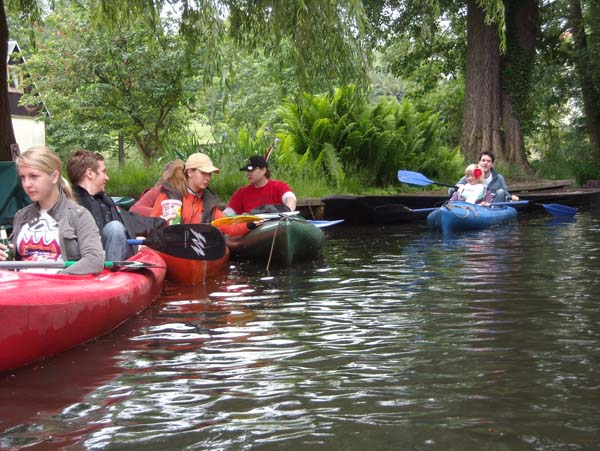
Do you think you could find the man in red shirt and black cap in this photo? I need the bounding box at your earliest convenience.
[223,155,296,215]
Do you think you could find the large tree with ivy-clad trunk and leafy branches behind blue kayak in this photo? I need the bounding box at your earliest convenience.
[368,0,539,166]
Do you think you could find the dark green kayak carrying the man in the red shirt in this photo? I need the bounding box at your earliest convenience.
[227,216,325,265]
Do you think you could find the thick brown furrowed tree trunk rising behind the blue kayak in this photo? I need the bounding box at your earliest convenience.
[461,0,504,161]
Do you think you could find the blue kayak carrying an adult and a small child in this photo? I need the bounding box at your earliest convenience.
[427,201,517,233]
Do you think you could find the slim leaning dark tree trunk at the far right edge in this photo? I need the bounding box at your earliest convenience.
[569,0,600,158]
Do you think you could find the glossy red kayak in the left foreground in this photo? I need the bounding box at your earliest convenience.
[0,248,166,371]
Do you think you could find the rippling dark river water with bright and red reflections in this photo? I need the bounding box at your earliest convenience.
[0,211,600,450]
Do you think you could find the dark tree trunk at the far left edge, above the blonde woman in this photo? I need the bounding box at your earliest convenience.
[0,0,19,161]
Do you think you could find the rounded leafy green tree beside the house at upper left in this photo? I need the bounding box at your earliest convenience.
[25,9,202,161]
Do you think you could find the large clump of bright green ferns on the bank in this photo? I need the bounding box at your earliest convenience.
[277,86,462,187]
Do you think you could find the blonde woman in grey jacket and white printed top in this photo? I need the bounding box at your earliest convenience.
[0,146,104,274]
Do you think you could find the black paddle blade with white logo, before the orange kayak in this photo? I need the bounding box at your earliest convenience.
[144,224,226,260]
